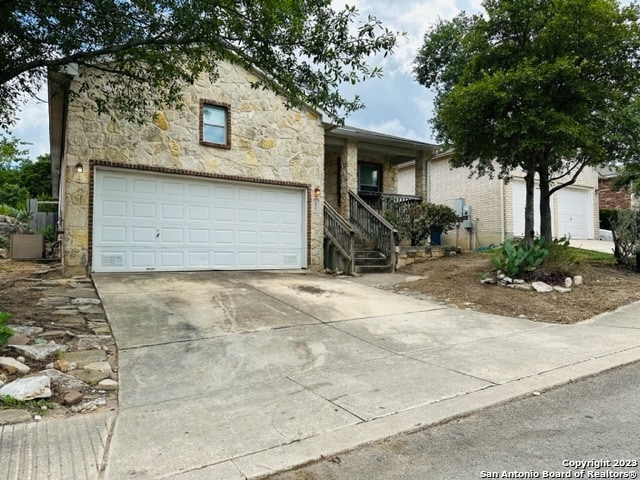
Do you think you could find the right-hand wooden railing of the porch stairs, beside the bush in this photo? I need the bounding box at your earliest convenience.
[349,191,398,269]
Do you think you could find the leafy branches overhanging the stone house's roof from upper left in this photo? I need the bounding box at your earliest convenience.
[0,0,396,128]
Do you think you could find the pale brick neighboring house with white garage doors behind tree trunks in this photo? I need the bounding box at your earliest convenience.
[427,152,598,248]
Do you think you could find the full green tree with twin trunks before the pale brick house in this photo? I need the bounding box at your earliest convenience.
[414,0,640,245]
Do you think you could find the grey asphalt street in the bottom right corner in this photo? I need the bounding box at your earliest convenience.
[268,363,640,480]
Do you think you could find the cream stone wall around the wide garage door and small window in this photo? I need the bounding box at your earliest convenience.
[62,63,324,274]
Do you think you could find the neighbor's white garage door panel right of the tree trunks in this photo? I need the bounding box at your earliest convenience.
[556,188,593,238]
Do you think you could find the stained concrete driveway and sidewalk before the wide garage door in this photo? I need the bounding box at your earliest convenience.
[94,272,640,480]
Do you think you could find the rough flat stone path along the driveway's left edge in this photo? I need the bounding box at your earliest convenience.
[0,269,118,426]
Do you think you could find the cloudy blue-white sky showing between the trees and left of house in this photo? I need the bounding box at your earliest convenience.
[2,0,480,159]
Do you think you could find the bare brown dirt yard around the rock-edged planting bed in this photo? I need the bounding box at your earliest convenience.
[398,252,640,323]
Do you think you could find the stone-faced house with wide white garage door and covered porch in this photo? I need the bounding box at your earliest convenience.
[49,63,435,275]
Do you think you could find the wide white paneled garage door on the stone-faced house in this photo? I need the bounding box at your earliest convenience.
[92,170,306,272]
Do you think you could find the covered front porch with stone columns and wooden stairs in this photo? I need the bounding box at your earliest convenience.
[324,127,436,273]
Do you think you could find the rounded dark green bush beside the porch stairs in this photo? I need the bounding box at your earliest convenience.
[383,203,459,245]
